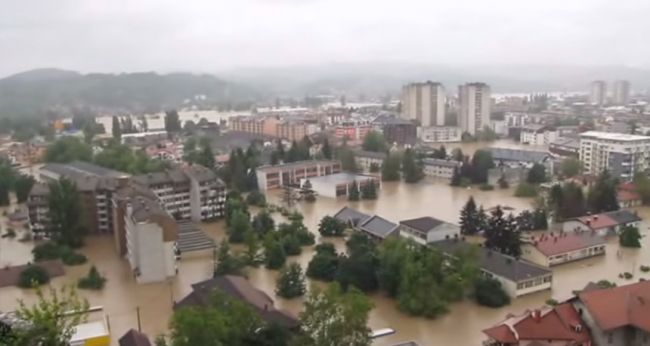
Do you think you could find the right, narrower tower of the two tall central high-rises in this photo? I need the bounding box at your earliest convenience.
[458,83,492,136]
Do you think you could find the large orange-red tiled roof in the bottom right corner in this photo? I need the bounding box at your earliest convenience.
[579,281,650,332]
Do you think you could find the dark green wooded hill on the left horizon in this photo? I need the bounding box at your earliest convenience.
[0,69,258,117]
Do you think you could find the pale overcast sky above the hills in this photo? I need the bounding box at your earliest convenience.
[0,0,650,76]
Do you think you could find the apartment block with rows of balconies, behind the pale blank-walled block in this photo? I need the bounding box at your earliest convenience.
[133,165,226,222]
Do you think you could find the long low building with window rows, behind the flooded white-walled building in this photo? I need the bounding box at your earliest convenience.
[255,160,341,191]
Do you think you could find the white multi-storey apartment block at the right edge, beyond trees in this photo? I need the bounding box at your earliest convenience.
[579,131,650,181]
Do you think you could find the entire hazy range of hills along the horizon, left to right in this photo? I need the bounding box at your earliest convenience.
[0,63,650,117]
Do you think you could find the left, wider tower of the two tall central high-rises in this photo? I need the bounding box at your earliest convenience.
[402,81,445,127]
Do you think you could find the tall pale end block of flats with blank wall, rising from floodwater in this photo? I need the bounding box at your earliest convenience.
[124,197,178,283]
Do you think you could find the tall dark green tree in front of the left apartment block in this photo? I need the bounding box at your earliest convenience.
[47,178,86,248]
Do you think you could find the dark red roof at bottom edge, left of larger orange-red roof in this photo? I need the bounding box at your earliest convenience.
[483,303,591,345]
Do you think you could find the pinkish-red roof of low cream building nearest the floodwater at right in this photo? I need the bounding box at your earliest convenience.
[533,232,605,256]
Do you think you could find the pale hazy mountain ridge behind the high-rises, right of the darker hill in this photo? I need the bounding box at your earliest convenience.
[221,63,650,96]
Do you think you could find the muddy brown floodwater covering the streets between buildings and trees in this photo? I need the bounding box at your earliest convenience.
[0,142,650,346]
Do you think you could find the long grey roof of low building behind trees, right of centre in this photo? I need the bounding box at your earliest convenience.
[432,239,552,282]
